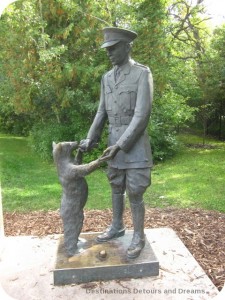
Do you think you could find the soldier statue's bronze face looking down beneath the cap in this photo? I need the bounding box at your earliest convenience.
[106,42,130,66]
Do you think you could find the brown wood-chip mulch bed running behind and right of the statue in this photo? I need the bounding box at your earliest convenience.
[4,208,225,290]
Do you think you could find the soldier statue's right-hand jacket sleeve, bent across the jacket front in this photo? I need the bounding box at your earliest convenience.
[116,68,153,152]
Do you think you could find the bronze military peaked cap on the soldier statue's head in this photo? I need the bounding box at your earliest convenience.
[101,27,137,48]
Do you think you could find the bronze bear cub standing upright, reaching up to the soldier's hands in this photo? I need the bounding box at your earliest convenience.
[52,142,101,257]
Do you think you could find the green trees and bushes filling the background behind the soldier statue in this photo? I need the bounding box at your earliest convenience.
[0,0,223,159]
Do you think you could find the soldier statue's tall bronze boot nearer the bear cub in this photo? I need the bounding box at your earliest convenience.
[97,193,125,242]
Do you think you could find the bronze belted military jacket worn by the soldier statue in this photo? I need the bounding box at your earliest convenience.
[87,60,153,169]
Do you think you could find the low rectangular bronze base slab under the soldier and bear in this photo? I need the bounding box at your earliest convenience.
[53,231,159,285]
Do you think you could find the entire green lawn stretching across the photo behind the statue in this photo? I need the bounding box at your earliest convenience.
[0,134,225,212]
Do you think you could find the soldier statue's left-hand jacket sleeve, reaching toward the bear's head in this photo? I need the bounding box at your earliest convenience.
[87,78,107,143]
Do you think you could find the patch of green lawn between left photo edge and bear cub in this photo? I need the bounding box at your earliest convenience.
[0,135,59,211]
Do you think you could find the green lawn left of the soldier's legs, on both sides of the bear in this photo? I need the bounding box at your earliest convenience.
[0,134,110,211]
